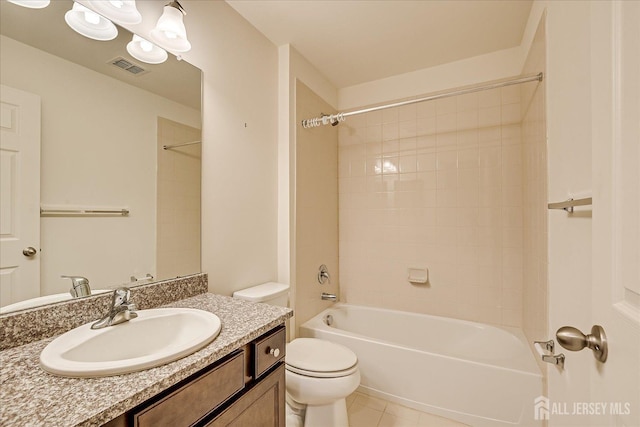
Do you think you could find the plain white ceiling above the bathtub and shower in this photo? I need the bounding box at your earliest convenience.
[227,0,532,88]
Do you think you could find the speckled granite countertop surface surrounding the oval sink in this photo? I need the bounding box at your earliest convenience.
[0,293,293,426]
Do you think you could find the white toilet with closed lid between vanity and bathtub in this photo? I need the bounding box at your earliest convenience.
[233,282,360,427]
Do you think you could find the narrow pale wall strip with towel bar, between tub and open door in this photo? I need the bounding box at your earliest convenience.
[531,1,593,426]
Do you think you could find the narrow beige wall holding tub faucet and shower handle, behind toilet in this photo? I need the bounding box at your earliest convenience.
[293,82,340,335]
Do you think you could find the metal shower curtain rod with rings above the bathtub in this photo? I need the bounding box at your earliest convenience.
[302,73,543,129]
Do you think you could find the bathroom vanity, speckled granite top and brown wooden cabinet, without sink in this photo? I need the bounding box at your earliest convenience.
[0,276,292,427]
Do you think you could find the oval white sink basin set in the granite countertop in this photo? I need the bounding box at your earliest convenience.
[40,308,221,377]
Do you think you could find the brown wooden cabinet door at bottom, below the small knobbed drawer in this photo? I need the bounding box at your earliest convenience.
[206,363,285,427]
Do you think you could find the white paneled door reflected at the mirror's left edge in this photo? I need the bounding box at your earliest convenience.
[0,85,40,306]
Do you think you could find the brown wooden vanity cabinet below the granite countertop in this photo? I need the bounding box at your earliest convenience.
[106,326,285,427]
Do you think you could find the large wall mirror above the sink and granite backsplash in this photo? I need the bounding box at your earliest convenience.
[0,0,202,312]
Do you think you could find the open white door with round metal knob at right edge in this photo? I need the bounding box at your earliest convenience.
[583,1,640,426]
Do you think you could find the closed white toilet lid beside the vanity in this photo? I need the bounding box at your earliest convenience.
[285,338,358,373]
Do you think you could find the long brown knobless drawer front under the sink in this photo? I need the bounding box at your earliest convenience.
[133,351,244,427]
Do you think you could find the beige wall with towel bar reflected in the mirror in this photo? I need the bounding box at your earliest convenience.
[0,36,200,294]
